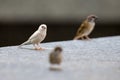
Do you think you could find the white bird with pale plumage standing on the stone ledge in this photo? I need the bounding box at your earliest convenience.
[19,24,47,50]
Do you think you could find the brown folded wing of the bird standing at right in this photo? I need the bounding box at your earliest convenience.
[76,20,88,36]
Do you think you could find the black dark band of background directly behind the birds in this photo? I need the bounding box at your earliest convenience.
[0,21,120,46]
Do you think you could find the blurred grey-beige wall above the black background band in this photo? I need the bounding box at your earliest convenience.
[0,0,120,20]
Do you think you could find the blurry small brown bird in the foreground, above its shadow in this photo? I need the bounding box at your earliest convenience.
[49,47,62,65]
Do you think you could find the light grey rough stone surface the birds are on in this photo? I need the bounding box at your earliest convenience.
[0,36,120,80]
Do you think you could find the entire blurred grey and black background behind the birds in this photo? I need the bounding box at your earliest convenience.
[0,0,120,46]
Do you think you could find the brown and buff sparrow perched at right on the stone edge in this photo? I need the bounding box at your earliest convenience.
[74,15,98,40]
